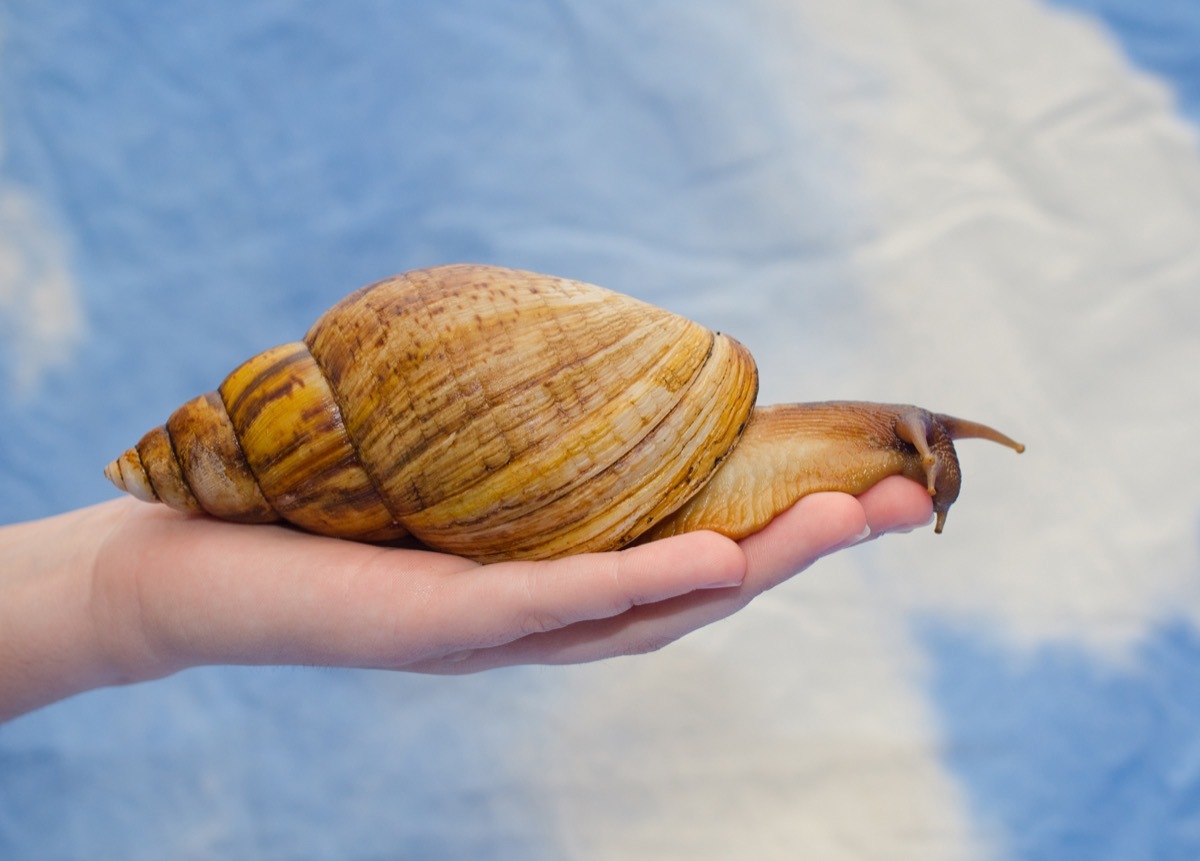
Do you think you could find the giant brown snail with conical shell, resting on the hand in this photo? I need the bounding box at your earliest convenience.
[104,264,1024,561]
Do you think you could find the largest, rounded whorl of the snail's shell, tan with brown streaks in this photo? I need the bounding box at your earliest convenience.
[306,265,757,561]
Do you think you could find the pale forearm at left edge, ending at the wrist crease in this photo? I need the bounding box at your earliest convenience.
[0,505,135,721]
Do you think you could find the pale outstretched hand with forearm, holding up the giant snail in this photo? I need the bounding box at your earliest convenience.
[0,476,932,721]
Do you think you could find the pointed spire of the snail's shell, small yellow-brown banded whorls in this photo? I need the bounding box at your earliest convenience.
[104,343,406,541]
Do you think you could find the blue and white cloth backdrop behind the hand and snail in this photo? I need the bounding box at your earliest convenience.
[0,0,1200,861]
